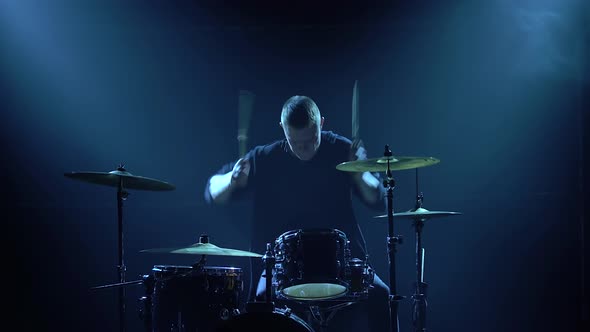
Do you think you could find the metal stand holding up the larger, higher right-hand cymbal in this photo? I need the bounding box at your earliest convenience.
[383,145,404,332]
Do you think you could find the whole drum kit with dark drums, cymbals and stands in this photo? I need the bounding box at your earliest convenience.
[64,149,461,332]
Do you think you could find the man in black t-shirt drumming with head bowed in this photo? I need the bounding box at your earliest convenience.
[205,95,390,332]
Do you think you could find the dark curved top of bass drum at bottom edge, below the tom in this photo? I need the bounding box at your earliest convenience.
[215,308,314,332]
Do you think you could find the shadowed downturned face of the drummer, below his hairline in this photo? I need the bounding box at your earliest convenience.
[281,118,324,160]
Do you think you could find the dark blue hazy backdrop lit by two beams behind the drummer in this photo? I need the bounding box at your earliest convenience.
[0,0,590,331]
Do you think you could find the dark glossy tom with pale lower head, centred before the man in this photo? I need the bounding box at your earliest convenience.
[273,229,350,300]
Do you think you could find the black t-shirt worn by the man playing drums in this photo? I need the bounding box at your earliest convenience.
[205,131,385,259]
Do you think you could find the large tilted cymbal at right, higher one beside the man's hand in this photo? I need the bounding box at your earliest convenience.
[336,156,440,172]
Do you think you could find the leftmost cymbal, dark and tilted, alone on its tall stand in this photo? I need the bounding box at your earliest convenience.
[64,167,176,191]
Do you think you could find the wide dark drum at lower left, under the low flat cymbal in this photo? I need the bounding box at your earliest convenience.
[148,265,243,332]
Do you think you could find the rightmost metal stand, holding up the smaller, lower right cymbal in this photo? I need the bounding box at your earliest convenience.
[412,169,428,332]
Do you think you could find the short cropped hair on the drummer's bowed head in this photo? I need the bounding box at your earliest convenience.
[281,95,321,129]
